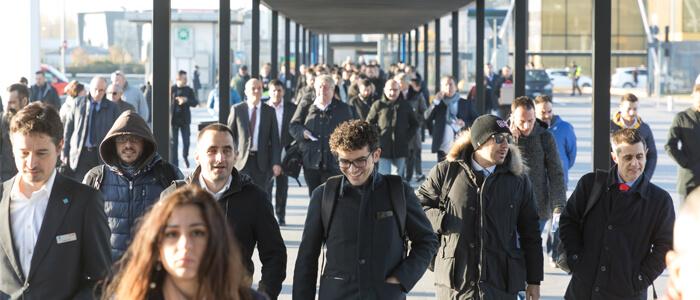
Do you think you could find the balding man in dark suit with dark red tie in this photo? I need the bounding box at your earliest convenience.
[228,78,282,191]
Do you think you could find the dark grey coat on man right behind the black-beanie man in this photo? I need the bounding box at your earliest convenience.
[517,120,566,220]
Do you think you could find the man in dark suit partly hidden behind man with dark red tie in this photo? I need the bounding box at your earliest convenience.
[267,80,297,225]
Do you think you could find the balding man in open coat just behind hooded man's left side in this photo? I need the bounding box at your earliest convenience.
[61,76,119,181]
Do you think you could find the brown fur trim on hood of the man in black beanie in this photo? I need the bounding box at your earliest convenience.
[447,131,528,176]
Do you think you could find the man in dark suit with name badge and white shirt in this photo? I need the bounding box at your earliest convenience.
[0,103,111,299]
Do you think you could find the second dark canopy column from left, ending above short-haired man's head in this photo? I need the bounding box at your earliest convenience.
[219,0,231,124]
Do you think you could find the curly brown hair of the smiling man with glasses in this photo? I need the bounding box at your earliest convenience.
[328,120,379,153]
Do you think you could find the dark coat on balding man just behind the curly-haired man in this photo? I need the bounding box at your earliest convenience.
[367,95,419,159]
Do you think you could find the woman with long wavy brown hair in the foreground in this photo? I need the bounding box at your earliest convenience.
[103,186,264,300]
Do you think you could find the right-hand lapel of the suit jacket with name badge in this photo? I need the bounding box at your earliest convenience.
[28,173,71,278]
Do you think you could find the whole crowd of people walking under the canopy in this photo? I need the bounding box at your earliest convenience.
[0,62,700,300]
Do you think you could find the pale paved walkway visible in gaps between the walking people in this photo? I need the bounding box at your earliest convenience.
[180,95,689,299]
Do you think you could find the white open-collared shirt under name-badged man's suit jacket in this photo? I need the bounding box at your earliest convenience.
[10,170,56,277]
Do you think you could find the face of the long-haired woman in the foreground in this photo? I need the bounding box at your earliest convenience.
[160,205,209,280]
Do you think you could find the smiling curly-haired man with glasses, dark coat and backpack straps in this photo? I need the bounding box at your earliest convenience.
[292,120,437,299]
